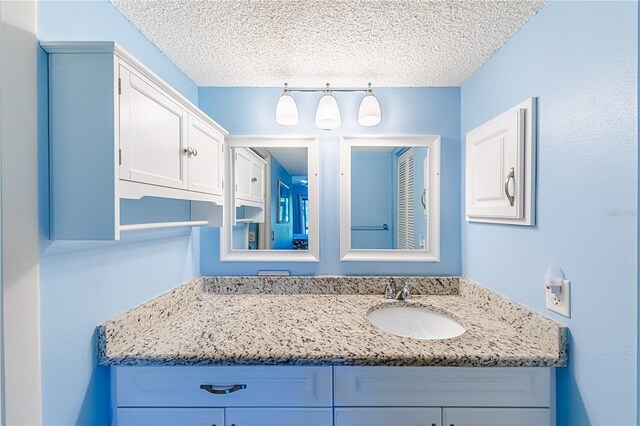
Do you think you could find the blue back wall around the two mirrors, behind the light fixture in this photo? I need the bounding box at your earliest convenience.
[198,87,461,275]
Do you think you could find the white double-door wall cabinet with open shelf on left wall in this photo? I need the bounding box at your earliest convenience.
[41,42,228,240]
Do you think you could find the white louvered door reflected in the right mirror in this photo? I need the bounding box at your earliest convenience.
[396,149,415,249]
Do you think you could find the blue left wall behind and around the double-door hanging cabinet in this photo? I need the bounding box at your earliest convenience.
[38,1,200,425]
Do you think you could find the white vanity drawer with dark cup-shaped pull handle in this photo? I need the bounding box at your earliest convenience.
[112,366,332,407]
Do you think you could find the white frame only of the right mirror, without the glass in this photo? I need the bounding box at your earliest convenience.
[340,135,440,262]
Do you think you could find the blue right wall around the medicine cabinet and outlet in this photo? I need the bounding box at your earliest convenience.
[461,1,638,425]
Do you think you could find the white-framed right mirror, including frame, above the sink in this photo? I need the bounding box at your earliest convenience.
[340,136,440,261]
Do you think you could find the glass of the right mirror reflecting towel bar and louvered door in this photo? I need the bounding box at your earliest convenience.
[351,146,429,250]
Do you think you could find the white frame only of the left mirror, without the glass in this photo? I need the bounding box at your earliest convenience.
[220,135,320,262]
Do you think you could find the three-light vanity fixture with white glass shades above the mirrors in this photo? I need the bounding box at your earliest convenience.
[276,83,381,130]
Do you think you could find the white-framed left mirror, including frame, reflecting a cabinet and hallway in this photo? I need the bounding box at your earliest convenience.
[221,136,319,261]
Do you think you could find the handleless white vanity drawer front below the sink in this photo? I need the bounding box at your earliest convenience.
[334,367,554,407]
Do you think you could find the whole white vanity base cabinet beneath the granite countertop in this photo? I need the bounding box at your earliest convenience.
[111,366,555,426]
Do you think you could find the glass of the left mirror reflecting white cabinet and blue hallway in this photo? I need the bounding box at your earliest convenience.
[231,146,309,250]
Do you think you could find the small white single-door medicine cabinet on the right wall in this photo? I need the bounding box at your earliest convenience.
[466,98,536,225]
